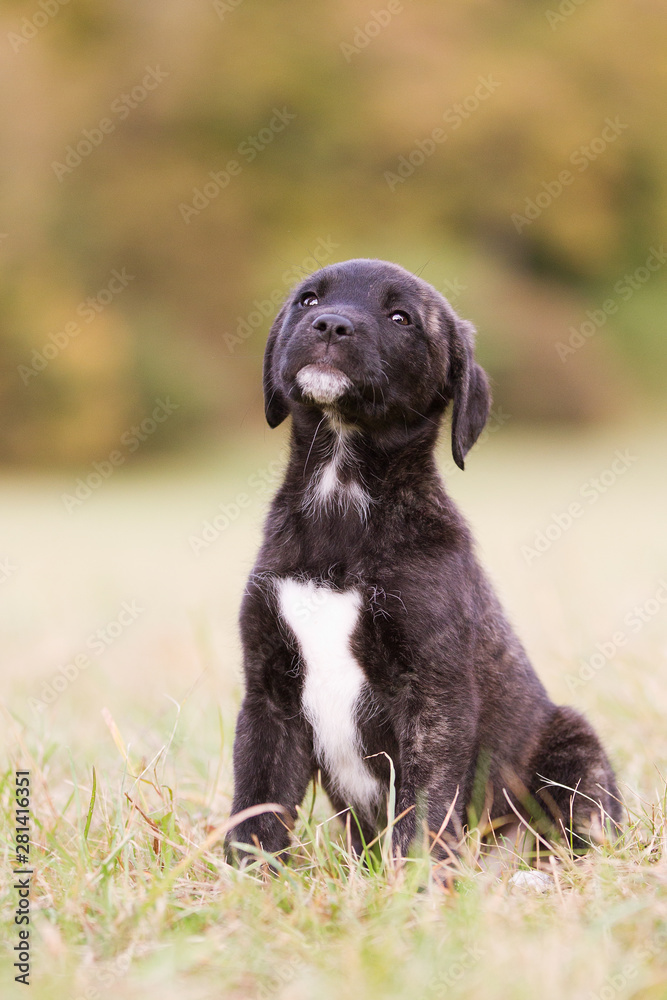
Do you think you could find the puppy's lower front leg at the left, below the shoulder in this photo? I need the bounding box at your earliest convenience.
[227,694,312,858]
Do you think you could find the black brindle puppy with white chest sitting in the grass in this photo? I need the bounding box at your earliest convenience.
[229,260,620,868]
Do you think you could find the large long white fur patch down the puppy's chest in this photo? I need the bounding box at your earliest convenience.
[278,579,381,812]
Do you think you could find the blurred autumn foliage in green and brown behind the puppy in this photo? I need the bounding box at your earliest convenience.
[0,0,667,465]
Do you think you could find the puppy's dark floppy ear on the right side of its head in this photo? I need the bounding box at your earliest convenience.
[445,315,491,469]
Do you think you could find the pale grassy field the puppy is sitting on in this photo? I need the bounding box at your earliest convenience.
[0,415,667,1000]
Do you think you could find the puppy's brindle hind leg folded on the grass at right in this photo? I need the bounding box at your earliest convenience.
[529,706,621,851]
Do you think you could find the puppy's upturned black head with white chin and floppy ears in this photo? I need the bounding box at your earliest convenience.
[264,260,490,468]
